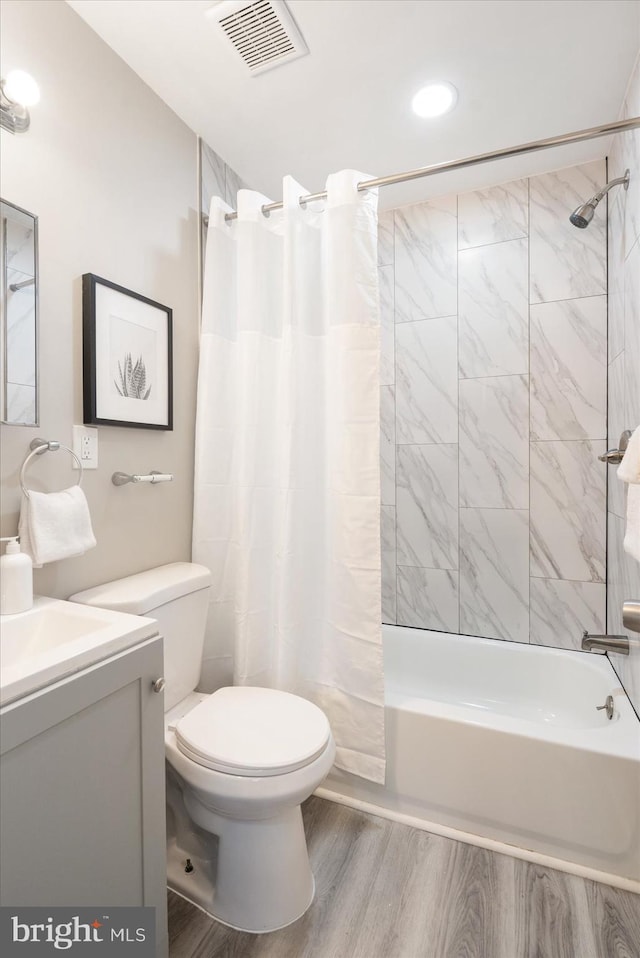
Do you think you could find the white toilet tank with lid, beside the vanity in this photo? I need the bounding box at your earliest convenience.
[69,562,211,710]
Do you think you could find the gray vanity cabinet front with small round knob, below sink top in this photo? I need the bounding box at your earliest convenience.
[0,637,167,956]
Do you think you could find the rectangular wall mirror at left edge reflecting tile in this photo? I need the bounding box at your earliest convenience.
[0,200,38,426]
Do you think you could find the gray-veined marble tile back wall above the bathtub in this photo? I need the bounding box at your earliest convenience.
[378,160,608,649]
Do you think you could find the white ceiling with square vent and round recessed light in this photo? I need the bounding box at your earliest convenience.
[68,0,640,207]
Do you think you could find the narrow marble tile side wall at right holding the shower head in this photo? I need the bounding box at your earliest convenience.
[607,50,640,715]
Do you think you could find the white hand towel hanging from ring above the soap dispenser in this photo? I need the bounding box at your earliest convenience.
[18,486,96,569]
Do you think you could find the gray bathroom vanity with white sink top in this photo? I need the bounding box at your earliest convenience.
[0,597,167,958]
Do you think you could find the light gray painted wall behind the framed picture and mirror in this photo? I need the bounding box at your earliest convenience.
[1,0,198,597]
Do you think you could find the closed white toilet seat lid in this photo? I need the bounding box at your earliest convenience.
[175,686,331,777]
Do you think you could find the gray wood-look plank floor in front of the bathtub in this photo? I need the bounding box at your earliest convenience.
[169,797,640,958]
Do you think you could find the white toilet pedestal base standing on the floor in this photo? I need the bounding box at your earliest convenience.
[167,795,315,934]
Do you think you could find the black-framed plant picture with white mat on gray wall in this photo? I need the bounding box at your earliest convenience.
[82,273,173,430]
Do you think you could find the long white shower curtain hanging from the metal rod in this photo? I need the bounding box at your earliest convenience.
[193,171,384,782]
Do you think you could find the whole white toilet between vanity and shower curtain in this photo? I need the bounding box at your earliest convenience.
[70,562,335,932]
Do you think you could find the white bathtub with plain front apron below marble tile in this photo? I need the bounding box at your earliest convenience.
[317,626,640,891]
